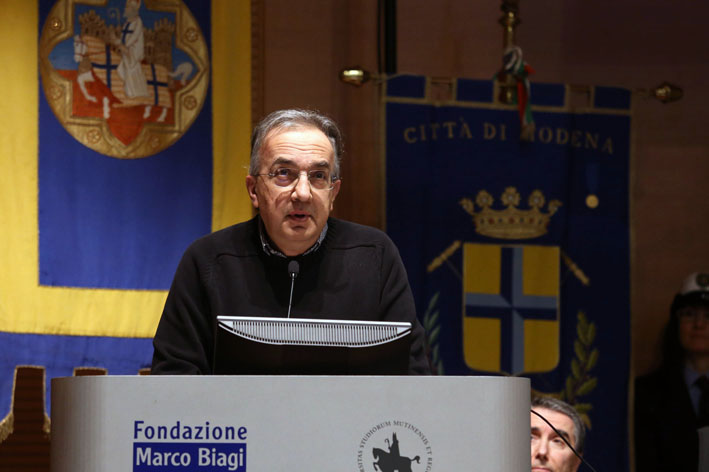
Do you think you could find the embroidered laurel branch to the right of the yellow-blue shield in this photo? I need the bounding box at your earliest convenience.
[559,311,598,428]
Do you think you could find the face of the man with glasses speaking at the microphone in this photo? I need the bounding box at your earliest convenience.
[246,127,341,256]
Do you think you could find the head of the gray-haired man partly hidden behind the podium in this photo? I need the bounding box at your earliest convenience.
[530,396,586,472]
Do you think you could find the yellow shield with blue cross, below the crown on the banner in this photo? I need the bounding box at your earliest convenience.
[463,243,560,375]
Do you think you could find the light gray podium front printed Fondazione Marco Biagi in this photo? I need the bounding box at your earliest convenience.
[51,376,530,472]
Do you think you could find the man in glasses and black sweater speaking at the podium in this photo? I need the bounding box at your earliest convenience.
[152,109,430,374]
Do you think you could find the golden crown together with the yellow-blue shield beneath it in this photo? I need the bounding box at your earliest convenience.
[429,187,561,375]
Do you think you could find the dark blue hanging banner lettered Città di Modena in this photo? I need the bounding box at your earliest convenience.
[384,76,631,470]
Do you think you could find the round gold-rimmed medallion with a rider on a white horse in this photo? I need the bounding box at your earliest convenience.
[39,0,209,158]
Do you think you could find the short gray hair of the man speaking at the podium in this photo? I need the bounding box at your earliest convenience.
[249,108,343,178]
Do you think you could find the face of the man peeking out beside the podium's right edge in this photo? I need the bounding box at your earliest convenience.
[530,407,581,472]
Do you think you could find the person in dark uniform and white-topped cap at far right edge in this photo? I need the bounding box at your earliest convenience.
[635,272,709,472]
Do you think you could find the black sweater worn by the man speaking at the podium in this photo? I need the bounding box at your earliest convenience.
[152,217,429,374]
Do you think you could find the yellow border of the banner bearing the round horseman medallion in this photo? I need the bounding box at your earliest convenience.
[0,0,251,337]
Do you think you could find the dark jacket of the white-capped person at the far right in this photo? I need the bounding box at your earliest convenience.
[635,369,699,472]
